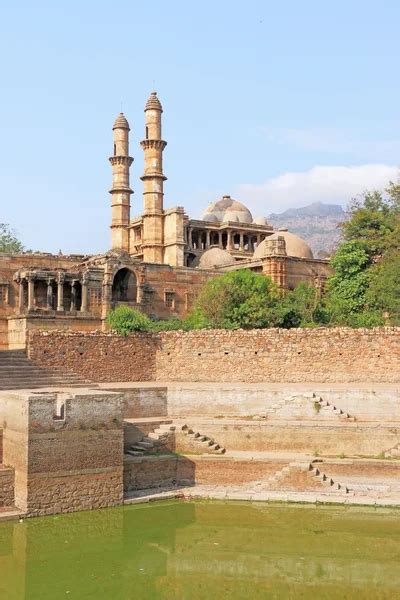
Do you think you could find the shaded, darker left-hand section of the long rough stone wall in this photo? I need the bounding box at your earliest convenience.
[28,331,157,382]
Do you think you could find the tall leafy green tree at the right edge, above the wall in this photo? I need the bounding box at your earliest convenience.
[326,183,400,327]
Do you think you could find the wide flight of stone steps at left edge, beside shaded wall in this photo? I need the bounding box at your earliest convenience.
[0,350,94,390]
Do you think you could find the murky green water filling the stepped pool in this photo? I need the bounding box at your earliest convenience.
[0,502,400,600]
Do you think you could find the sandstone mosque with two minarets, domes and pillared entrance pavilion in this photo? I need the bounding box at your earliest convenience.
[0,92,329,349]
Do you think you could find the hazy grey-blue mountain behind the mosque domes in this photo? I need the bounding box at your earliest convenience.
[267,202,346,256]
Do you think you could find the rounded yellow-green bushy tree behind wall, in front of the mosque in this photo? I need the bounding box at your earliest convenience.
[196,269,280,329]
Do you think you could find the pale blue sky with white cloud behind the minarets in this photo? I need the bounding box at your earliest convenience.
[0,0,400,253]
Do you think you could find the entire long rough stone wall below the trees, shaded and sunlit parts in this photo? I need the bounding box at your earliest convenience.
[28,327,400,383]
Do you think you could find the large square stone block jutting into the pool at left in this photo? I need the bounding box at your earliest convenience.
[0,390,123,515]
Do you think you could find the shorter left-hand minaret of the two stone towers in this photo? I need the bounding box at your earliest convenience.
[109,113,133,252]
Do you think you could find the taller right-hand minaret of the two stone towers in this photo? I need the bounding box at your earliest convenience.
[140,92,167,263]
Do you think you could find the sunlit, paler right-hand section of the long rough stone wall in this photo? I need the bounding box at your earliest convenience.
[156,327,400,383]
